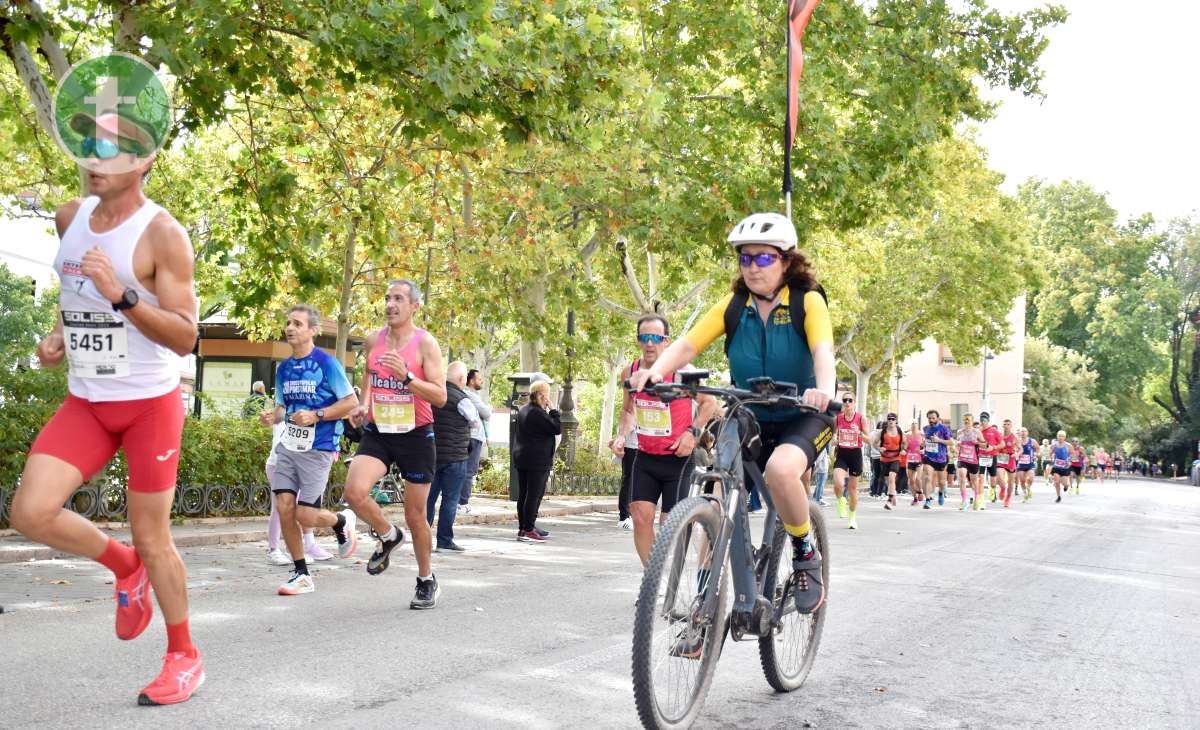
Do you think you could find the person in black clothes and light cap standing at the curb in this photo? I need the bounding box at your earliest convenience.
[512,382,563,543]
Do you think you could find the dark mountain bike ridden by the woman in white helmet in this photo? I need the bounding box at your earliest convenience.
[632,370,841,730]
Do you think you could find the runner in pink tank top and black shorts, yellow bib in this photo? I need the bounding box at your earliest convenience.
[346,280,446,609]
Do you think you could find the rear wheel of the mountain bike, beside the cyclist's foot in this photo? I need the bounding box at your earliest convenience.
[758,502,829,692]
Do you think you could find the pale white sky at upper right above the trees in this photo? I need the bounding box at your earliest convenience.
[979,0,1200,222]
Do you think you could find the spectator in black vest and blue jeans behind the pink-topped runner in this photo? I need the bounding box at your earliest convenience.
[425,361,479,552]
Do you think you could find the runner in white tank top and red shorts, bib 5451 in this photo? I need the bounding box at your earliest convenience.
[12,124,204,705]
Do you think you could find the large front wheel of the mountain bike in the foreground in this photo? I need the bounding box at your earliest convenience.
[634,497,728,730]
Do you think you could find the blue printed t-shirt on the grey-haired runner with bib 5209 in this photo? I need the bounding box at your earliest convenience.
[275,347,354,451]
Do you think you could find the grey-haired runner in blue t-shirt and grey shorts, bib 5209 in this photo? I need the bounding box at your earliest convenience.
[260,304,359,596]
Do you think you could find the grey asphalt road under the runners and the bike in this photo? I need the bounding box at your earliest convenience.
[0,480,1200,730]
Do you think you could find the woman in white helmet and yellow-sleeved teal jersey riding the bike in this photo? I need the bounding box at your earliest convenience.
[629,213,836,614]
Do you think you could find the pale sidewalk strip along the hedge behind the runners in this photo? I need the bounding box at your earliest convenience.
[0,495,617,563]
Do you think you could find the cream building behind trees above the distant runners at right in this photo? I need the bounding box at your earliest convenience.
[888,294,1025,427]
